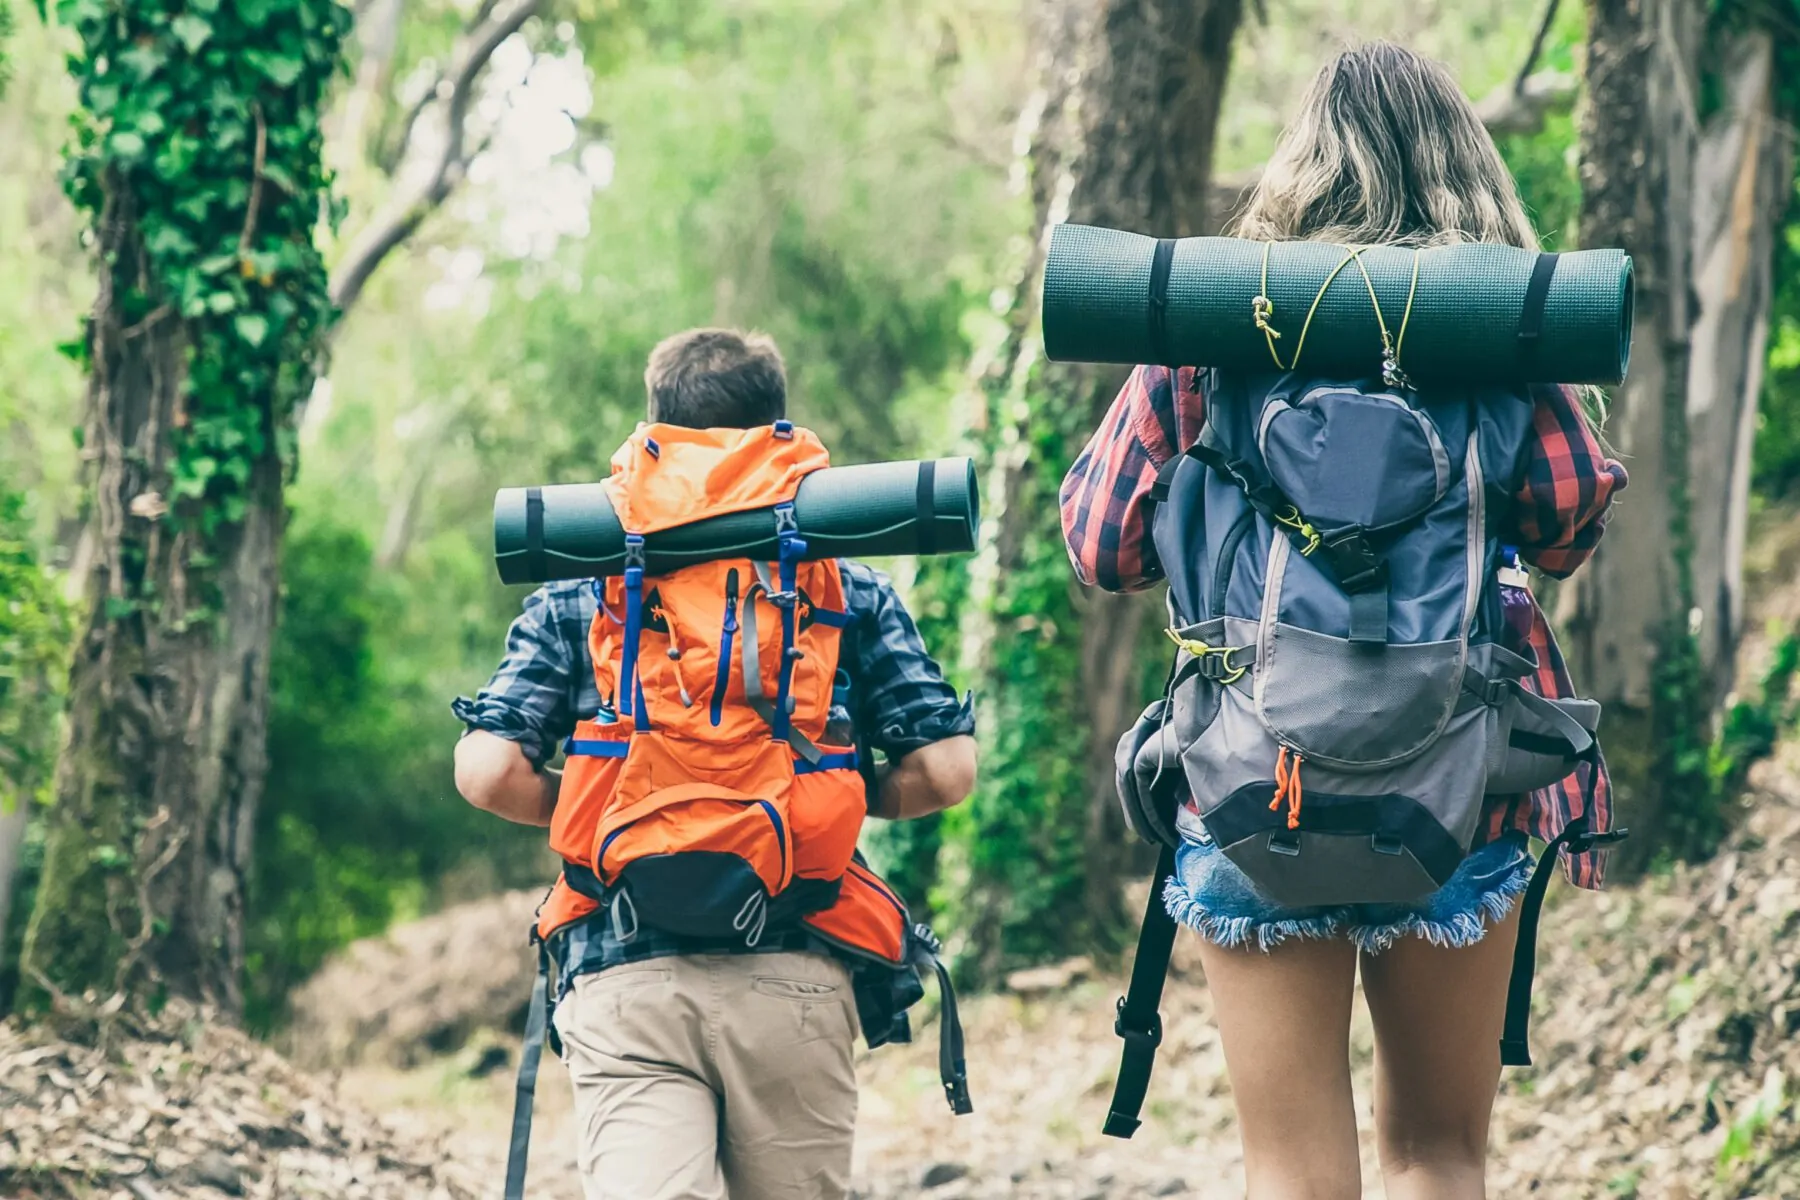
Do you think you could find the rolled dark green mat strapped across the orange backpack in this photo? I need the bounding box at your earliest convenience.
[493,459,981,583]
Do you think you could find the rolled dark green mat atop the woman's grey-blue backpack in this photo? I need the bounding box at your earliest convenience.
[1044,225,1633,385]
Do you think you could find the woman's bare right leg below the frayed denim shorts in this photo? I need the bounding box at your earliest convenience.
[1363,909,1519,1200]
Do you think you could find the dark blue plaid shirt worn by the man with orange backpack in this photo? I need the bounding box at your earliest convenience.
[450,560,976,995]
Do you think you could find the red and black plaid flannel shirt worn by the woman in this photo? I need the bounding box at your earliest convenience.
[1062,367,1625,887]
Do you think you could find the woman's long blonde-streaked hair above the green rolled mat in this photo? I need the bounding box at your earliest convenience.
[1231,41,1539,250]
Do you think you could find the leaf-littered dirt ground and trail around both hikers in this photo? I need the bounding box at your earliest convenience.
[10,745,1800,1200]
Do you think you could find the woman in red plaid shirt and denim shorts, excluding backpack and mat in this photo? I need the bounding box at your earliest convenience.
[1062,43,1625,1200]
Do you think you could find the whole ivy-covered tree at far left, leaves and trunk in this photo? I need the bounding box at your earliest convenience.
[23,0,351,1009]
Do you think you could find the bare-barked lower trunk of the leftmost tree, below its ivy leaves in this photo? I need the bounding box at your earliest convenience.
[23,187,283,1009]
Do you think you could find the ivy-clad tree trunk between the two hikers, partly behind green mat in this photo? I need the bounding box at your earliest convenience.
[958,0,1242,973]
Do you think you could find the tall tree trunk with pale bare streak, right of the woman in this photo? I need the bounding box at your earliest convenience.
[1561,0,1791,865]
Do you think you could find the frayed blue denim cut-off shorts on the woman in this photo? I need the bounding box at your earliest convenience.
[1163,833,1534,954]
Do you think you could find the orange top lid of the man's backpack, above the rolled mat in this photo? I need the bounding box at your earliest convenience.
[605,421,832,534]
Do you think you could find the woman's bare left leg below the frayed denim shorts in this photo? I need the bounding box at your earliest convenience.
[1201,939,1363,1200]
